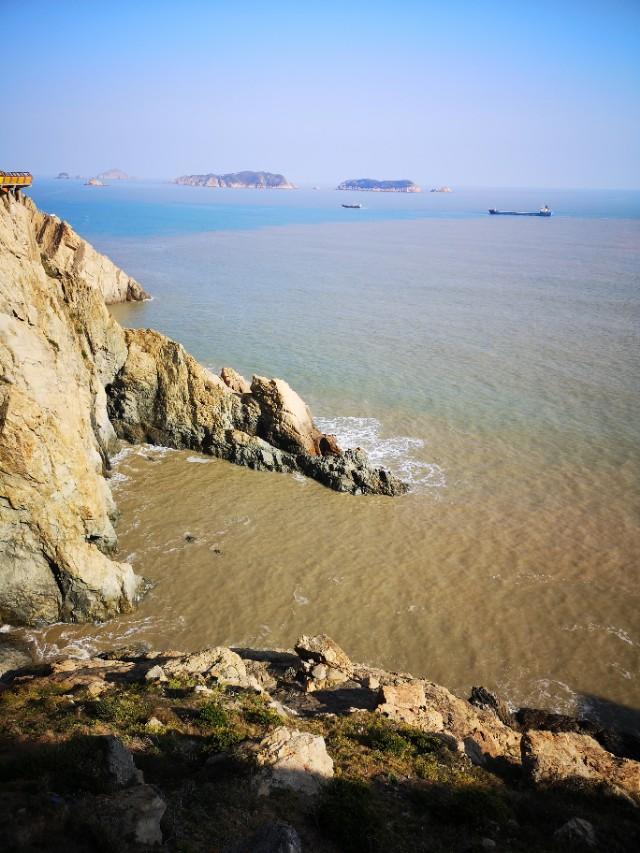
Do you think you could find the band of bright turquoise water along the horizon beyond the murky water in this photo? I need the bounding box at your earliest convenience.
[31,178,640,240]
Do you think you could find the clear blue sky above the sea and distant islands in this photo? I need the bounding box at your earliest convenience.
[0,0,640,188]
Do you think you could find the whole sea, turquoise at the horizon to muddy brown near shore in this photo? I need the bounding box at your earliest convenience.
[10,178,640,730]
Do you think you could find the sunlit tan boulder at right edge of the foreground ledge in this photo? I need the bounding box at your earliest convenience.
[522,731,640,804]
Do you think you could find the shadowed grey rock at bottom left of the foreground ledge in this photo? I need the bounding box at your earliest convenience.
[85,785,167,847]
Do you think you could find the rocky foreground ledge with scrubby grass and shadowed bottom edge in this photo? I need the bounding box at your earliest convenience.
[0,635,640,853]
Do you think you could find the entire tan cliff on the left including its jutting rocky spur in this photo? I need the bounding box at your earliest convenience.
[0,195,405,624]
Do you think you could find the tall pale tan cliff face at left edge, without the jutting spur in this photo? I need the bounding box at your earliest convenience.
[0,190,141,624]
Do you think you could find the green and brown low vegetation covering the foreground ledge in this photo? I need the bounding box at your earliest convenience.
[0,678,640,853]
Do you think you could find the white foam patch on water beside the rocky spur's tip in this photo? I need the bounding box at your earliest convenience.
[315,417,447,489]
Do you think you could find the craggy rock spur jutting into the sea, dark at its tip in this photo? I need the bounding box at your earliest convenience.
[107,329,406,495]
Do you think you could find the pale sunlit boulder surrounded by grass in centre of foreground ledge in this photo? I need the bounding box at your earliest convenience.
[256,726,333,795]
